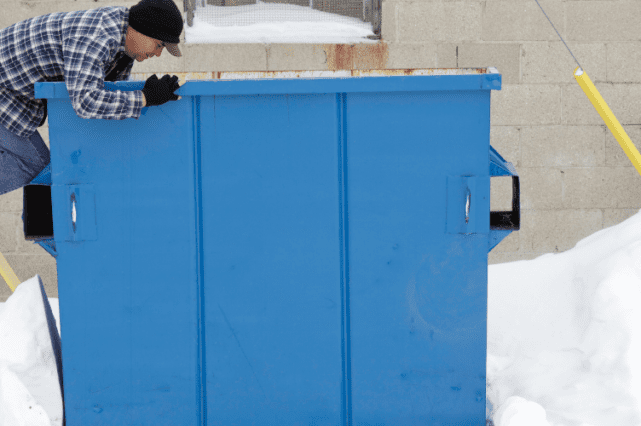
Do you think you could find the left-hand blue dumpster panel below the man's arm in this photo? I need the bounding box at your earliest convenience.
[48,99,199,426]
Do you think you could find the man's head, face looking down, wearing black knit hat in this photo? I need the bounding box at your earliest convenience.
[125,0,183,62]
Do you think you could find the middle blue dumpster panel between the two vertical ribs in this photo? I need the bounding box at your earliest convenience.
[201,94,342,426]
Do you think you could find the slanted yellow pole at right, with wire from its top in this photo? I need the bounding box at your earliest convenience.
[574,67,641,175]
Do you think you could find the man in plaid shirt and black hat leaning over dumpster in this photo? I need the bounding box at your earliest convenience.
[0,0,183,195]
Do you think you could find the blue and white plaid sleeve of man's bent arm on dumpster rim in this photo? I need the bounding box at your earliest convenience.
[62,35,142,120]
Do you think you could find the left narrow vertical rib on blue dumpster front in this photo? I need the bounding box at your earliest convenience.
[192,96,207,426]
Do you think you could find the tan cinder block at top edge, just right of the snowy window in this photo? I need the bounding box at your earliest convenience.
[397,2,481,43]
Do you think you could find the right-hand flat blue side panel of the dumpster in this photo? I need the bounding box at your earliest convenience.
[346,90,490,426]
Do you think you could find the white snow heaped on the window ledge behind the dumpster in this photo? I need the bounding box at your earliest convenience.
[185,1,378,44]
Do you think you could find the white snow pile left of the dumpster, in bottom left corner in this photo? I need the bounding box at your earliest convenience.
[0,275,62,426]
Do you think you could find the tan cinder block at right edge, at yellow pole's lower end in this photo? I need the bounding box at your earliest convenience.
[562,167,641,209]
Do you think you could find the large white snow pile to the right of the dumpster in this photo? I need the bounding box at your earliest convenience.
[487,213,641,426]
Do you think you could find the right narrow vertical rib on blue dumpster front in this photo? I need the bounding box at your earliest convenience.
[336,93,352,426]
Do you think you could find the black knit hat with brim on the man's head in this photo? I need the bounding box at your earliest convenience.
[129,0,183,56]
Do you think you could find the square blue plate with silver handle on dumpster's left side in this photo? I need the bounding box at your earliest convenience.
[51,184,98,241]
